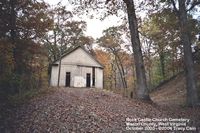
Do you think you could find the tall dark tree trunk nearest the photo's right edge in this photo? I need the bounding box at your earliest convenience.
[179,0,198,107]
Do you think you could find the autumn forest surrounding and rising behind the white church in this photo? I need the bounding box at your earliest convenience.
[0,0,200,106]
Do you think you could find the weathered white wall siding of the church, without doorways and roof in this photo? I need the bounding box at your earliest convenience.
[50,48,103,88]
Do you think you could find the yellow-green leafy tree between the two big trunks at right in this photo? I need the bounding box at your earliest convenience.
[140,9,181,80]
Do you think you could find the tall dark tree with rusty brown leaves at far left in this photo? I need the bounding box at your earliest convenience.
[0,0,52,92]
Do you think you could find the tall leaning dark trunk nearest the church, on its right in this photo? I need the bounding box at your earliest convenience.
[124,0,150,100]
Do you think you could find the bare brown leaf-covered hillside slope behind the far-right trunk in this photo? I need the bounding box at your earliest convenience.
[151,65,200,106]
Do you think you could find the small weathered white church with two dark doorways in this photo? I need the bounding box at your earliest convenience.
[50,46,103,88]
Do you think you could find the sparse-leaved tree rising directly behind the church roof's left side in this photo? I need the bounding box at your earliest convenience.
[42,3,93,64]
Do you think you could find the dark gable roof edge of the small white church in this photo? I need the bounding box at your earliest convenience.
[52,45,104,68]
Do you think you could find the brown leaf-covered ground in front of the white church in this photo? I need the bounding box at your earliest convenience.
[0,88,200,133]
